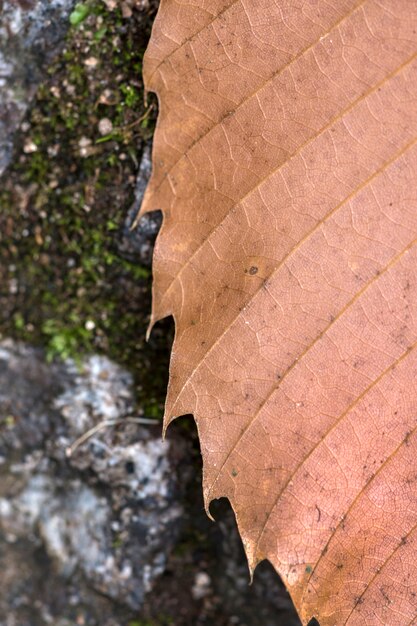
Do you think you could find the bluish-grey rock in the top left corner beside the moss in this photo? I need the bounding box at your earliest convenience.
[0,0,74,174]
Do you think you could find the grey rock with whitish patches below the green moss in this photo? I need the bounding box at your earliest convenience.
[0,341,183,625]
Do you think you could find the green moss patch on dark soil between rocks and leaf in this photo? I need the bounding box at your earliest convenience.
[0,0,170,416]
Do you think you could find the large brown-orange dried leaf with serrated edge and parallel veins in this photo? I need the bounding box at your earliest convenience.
[142,0,417,626]
